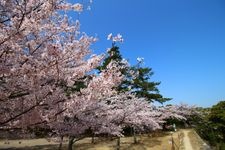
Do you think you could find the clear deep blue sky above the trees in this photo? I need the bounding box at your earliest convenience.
[73,0,225,107]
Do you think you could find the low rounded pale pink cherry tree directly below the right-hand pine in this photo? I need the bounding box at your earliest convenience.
[103,92,161,147]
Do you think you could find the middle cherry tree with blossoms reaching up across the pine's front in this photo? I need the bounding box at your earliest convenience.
[47,60,125,149]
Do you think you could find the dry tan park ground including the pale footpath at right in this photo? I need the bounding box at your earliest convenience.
[0,129,209,150]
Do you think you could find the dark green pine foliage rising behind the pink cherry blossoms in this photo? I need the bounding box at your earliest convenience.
[97,43,170,103]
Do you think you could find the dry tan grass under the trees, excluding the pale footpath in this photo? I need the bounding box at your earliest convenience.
[0,132,183,150]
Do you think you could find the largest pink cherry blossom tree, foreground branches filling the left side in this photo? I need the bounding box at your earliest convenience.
[0,0,103,127]
